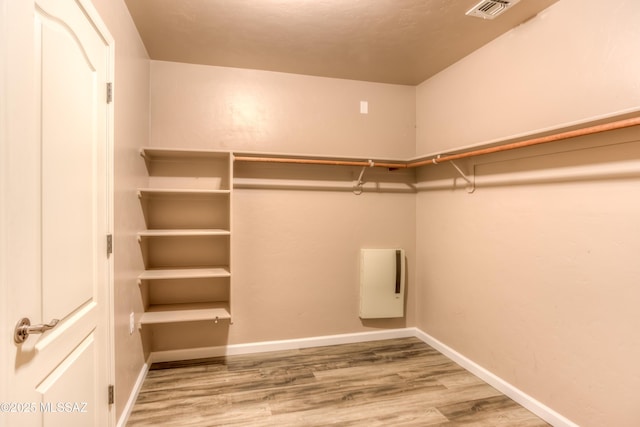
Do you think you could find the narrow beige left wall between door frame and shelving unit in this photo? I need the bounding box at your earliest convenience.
[92,0,149,418]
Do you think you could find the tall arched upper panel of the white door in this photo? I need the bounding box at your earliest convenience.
[36,6,99,319]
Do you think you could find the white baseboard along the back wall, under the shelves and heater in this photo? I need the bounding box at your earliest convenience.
[149,328,415,363]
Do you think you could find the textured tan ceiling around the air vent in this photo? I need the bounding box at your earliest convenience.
[125,0,557,85]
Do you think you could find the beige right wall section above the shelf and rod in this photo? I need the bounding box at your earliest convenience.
[416,0,640,155]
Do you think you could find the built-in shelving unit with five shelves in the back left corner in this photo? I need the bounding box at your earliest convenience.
[138,148,233,329]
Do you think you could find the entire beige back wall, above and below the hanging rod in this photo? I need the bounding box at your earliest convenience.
[151,61,415,350]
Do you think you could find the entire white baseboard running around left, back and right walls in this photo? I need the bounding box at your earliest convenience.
[117,328,578,427]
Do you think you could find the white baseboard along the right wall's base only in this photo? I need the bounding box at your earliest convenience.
[415,328,578,427]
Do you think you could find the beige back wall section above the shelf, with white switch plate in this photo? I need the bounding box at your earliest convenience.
[151,61,415,158]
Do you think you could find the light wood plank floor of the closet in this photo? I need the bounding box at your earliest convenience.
[127,338,548,427]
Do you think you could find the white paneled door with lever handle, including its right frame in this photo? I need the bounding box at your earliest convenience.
[0,0,114,427]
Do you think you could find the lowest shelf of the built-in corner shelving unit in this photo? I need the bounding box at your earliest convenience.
[140,302,231,325]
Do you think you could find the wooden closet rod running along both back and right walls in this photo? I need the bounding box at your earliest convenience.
[235,116,640,169]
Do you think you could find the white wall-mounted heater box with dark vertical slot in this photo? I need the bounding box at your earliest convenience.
[360,249,406,319]
